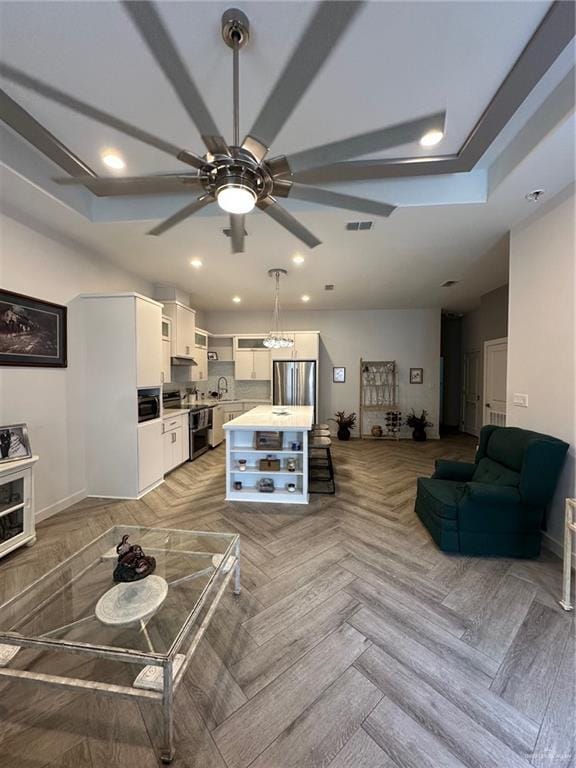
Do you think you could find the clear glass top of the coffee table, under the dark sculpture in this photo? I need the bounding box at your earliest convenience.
[0,526,238,656]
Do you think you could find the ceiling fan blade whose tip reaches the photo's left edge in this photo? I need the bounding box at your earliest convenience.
[0,62,206,168]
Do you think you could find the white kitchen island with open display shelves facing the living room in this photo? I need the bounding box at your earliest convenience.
[224,405,314,504]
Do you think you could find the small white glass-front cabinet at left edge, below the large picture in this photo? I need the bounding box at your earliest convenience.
[0,456,38,557]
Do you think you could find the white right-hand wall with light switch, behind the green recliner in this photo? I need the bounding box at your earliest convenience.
[507,187,576,551]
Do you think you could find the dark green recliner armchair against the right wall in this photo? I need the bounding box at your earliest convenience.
[416,425,568,557]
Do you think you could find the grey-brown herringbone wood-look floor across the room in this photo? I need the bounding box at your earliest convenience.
[0,436,576,768]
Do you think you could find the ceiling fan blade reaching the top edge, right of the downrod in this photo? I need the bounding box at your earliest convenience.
[243,0,364,160]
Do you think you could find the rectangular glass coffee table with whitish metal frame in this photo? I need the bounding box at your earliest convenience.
[0,526,240,763]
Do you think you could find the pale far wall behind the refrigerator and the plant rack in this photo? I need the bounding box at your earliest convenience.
[205,309,440,437]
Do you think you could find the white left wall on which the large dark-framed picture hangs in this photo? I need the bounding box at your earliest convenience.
[0,216,151,516]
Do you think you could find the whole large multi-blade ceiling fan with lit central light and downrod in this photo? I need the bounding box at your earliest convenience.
[0,0,445,253]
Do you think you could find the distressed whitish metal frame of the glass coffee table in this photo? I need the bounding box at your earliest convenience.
[0,526,241,763]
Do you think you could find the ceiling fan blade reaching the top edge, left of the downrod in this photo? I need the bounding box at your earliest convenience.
[122,0,225,151]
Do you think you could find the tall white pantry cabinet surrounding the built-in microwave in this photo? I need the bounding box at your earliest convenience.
[79,293,163,499]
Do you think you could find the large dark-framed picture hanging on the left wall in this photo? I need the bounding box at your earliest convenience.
[0,290,67,368]
